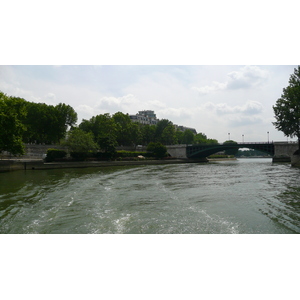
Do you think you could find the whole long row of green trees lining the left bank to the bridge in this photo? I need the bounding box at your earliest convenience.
[0,92,218,154]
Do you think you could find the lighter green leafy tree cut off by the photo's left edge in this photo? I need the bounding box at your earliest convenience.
[0,92,26,155]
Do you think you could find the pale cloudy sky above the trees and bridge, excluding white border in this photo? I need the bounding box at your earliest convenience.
[0,65,297,142]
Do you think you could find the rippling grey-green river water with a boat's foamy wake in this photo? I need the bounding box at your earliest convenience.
[0,158,300,234]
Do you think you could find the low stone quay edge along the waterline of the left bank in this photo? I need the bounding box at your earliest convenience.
[0,159,208,172]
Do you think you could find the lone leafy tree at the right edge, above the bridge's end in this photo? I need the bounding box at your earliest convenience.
[273,66,300,154]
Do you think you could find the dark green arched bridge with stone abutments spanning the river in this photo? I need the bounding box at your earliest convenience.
[167,142,298,162]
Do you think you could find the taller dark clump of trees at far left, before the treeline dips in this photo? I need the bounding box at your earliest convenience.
[0,92,77,154]
